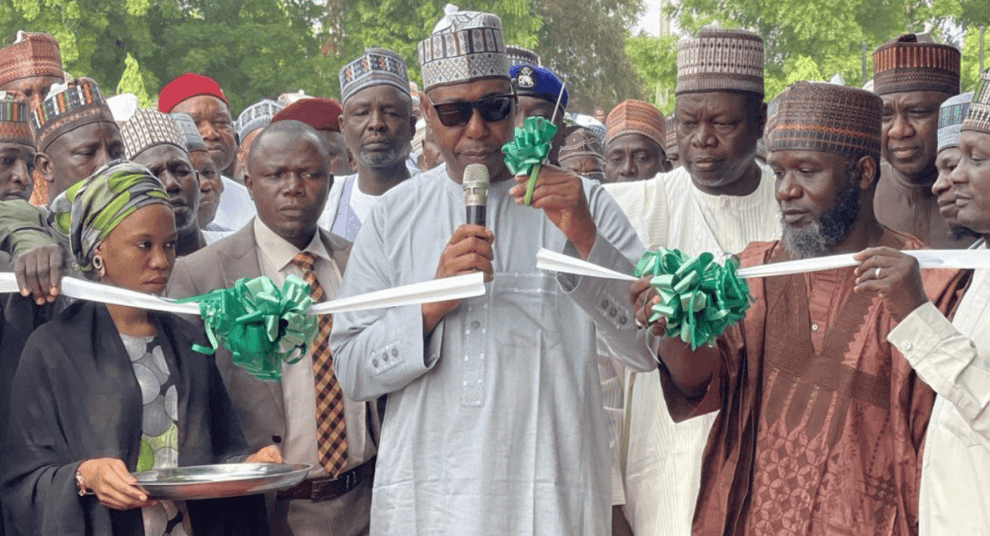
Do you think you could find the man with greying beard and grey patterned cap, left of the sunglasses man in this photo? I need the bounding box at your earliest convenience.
[319,48,416,240]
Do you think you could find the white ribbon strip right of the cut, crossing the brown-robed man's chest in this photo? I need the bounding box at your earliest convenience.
[536,249,990,281]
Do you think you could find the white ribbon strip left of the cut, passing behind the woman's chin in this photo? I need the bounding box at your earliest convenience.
[0,272,485,315]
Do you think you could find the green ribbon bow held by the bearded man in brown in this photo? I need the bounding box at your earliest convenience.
[633,248,750,350]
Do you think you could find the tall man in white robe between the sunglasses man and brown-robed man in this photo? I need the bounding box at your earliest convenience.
[605,23,781,536]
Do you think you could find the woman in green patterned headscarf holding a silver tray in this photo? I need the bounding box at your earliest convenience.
[0,162,280,536]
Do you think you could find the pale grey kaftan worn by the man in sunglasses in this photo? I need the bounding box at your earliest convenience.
[331,166,655,536]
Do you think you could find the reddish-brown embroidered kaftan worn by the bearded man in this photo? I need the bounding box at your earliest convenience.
[660,229,964,535]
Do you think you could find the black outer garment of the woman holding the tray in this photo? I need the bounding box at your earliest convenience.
[0,302,268,536]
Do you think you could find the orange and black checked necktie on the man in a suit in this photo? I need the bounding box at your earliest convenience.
[292,251,347,477]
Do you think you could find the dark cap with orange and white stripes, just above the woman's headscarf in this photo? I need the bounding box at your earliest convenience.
[31,78,117,152]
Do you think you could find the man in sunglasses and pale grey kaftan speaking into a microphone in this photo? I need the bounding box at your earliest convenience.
[330,6,655,536]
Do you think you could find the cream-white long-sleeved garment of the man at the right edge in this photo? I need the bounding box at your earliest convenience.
[887,240,990,536]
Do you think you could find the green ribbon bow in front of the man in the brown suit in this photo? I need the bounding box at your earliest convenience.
[178,275,317,381]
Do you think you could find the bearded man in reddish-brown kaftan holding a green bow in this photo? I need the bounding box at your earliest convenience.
[631,82,963,535]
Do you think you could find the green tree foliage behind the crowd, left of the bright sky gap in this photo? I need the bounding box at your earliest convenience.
[0,0,641,114]
